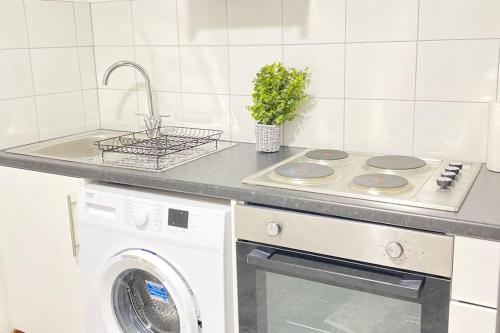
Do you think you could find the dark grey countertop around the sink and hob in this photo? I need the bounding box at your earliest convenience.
[0,143,500,241]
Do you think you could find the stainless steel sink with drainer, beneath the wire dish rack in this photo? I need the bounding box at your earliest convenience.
[7,127,236,172]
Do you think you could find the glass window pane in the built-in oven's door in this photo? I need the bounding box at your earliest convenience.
[257,271,422,333]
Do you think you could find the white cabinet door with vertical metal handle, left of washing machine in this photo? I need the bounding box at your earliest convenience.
[0,167,83,333]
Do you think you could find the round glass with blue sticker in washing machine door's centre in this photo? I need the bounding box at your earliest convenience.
[112,269,181,333]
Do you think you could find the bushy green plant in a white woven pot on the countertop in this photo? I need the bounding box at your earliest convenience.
[247,63,309,152]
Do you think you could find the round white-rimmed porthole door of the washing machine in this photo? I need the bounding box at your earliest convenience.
[101,250,201,333]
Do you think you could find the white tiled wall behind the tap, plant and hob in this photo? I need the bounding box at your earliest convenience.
[0,0,492,160]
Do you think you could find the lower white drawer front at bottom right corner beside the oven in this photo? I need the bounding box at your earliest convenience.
[448,301,497,333]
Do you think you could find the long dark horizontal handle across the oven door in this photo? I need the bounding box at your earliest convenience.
[247,248,424,299]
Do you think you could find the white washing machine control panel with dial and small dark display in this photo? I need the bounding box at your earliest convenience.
[80,184,230,252]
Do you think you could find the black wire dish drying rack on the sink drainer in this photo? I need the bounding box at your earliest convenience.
[95,126,223,170]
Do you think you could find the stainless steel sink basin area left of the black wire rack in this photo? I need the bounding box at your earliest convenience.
[7,130,125,163]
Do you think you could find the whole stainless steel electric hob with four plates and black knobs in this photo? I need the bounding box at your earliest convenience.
[243,149,481,211]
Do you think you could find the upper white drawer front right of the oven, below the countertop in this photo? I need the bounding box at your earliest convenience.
[451,237,500,308]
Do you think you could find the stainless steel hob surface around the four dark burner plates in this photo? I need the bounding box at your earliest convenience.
[243,150,481,212]
